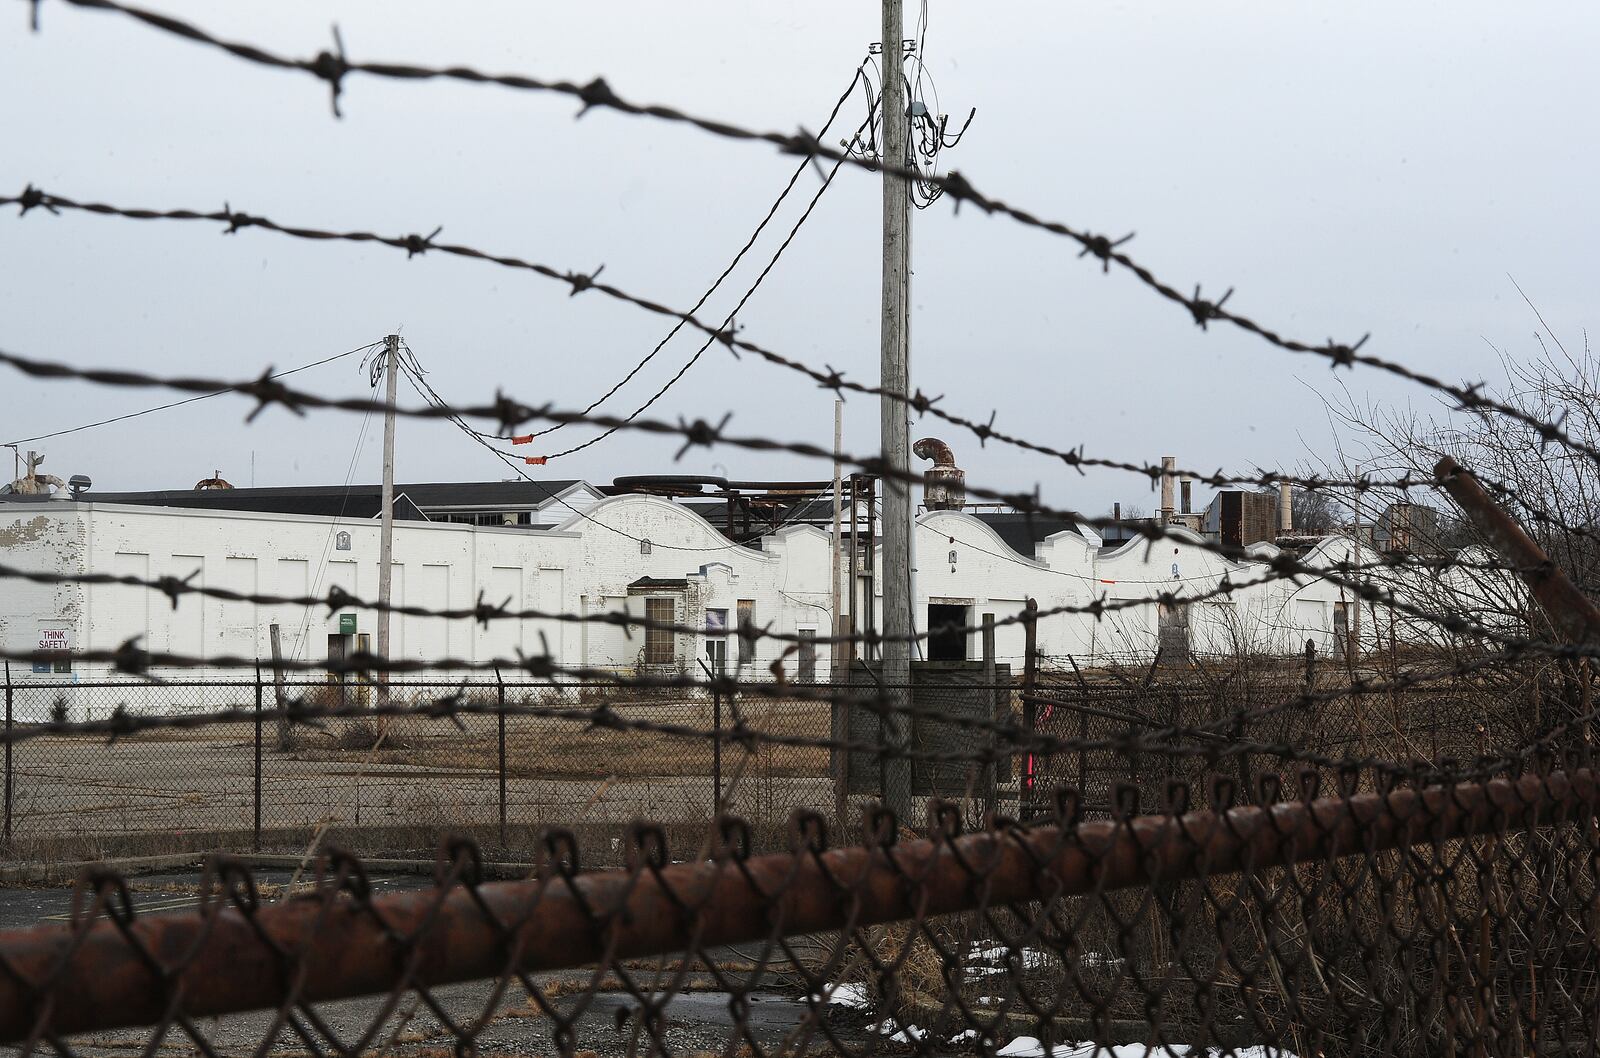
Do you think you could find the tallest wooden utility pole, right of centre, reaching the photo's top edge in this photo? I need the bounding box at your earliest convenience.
[878,0,912,824]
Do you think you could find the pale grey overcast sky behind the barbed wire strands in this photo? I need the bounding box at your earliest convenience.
[0,0,1600,512]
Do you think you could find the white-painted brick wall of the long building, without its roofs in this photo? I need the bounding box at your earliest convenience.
[0,496,1465,704]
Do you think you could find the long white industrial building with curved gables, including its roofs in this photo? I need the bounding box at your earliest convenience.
[0,467,1414,701]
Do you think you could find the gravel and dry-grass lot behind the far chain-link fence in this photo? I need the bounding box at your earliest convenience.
[11,704,834,858]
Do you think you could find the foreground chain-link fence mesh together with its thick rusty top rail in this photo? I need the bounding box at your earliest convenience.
[0,760,1600,1055]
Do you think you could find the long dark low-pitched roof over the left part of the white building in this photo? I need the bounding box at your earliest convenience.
[83,479,578,520]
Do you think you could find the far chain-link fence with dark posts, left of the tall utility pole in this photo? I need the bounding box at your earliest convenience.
[5,677,979,861]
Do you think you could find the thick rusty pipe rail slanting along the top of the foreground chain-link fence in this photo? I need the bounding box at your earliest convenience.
[0,768,1597,1042]
